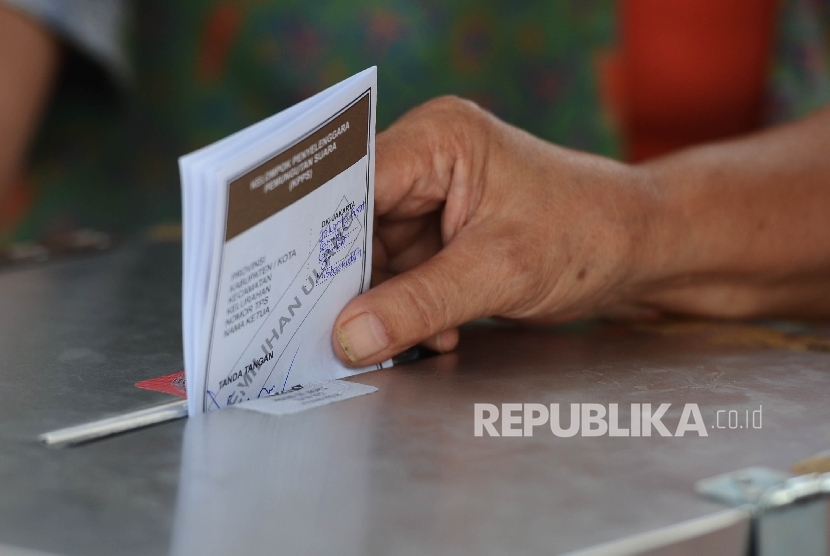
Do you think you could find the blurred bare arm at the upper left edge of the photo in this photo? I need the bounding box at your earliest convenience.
[0,4,60,202]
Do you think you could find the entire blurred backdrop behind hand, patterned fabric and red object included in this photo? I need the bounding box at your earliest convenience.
[0,0,830,263]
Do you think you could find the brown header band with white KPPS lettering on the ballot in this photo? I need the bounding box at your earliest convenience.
[225,93,369,241]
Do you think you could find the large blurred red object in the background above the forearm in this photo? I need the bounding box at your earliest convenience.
[600,0,778,162]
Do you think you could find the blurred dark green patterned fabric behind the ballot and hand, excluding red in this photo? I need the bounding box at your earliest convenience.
[0,0,830,248]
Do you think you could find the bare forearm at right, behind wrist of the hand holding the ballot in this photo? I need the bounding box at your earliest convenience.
[631,108,830,317]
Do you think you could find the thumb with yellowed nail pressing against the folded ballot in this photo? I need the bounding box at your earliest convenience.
[332,229,499,366]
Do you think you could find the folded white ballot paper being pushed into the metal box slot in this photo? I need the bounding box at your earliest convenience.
[179,68,388,415]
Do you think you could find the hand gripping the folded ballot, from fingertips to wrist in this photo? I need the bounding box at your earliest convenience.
[332,97,653,366]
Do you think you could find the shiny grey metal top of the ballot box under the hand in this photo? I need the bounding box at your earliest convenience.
[0,245,830,554]
